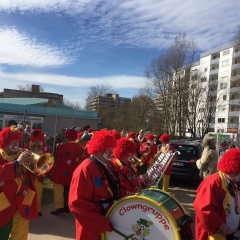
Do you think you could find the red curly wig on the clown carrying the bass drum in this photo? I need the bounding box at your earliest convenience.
[88,130,117,154]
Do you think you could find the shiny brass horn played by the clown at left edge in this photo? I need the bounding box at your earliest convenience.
[20,149,54,176]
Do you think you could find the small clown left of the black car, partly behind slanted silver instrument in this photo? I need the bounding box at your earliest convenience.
[158,133,174,192]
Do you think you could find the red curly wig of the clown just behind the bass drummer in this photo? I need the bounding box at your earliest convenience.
[113,138,136,160]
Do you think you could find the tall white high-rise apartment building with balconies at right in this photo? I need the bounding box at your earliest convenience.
[193,42,240,138]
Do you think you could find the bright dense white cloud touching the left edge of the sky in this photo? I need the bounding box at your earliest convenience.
[0,28,71,67]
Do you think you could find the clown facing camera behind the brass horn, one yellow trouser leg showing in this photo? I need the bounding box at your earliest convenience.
[23,129,50,217]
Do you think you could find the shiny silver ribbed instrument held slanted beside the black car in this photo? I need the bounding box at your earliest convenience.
[142,151,178,188]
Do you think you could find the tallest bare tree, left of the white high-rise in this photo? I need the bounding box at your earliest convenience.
[145,33,197,138]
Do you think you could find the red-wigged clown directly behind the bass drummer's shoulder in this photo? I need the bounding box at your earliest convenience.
[111,138,140,197]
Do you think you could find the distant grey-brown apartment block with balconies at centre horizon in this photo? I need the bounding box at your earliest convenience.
[89,93,132,111]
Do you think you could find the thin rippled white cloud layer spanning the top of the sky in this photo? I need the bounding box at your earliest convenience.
[0,0,240,50]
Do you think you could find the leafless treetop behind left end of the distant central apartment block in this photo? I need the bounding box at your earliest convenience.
[85,85,116,110]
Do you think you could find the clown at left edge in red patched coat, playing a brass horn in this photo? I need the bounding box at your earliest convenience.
[0,126,38,240]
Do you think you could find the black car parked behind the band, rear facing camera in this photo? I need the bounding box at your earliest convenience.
[170,140,203,181]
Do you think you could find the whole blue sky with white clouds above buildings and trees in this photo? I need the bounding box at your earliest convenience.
[0,0,240,107]
